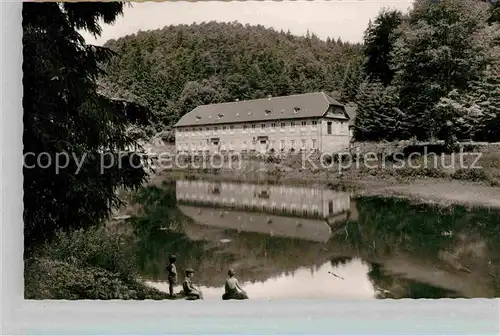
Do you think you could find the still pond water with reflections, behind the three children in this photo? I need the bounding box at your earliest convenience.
[131,180,500,300]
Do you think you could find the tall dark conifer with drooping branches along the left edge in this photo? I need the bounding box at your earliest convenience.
[22,2,152,249]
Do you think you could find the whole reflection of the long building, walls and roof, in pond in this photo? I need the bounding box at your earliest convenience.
[176,180,350,242]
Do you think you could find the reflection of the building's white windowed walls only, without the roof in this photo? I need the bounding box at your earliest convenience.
[176,180,350,219]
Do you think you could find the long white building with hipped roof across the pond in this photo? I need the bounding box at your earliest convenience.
[174,92,351,153]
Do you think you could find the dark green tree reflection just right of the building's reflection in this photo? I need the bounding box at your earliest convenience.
[342,197,500,256]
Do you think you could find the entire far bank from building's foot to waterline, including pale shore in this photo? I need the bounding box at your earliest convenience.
[149,143,500,211]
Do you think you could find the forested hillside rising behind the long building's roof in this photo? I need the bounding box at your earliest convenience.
[103,22,362,129]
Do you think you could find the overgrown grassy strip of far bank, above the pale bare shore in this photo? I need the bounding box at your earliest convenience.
[153,144,500,187]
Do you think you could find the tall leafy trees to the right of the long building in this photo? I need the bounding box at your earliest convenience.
[355,0,500,143]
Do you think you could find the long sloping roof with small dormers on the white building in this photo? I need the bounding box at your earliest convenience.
[174,92,343,127]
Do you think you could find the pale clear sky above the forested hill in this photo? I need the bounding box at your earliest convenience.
[82,0,413,45]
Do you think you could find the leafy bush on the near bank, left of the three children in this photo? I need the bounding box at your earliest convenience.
[24,228,167,300]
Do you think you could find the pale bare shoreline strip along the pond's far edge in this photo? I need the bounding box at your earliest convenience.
[152,169,500,209]
